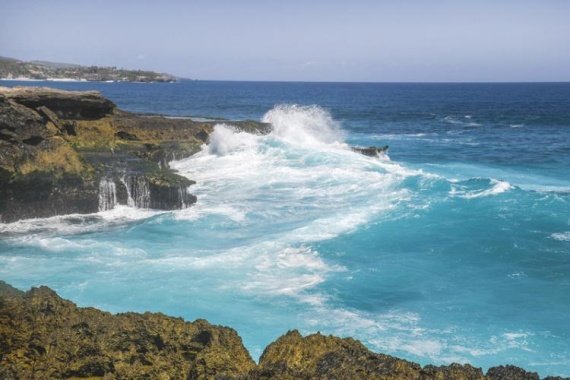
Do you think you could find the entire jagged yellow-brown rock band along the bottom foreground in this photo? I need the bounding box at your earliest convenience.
[0,281,569,380]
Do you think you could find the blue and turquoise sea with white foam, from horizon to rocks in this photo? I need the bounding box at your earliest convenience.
[0,81,570,376]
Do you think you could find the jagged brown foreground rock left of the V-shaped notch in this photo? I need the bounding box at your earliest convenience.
[0,282,255,379]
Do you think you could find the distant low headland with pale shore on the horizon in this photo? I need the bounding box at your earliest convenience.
[0,57,178,83]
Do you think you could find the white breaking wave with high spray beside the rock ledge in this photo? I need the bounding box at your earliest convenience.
[172,106,410,236]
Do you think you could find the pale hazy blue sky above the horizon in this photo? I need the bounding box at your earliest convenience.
[0,0,570,82]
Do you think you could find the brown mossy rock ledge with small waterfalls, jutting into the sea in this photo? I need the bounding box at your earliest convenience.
[0,87,269,222]
